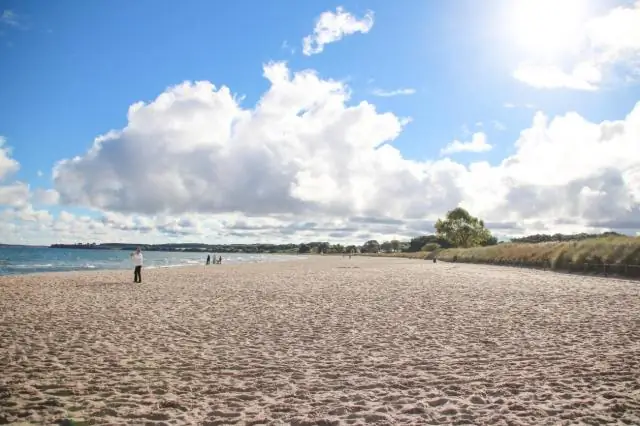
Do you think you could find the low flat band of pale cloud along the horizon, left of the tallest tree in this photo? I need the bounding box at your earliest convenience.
[0,204,433,244]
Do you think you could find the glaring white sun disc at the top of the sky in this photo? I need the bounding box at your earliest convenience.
[507,0,589,56]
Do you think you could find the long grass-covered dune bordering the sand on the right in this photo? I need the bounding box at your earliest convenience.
[364,237,640,277]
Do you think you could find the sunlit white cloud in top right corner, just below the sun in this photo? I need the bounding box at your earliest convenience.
[513,1,640,91]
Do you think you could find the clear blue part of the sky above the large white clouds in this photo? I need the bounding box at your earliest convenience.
[0,0,640,243]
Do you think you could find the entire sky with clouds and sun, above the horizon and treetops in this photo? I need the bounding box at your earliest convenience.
[0,0,640,244]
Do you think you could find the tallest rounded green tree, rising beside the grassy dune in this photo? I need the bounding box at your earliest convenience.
[434,207,491,248]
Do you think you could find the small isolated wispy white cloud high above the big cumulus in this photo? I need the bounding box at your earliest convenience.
[302,6,373,56]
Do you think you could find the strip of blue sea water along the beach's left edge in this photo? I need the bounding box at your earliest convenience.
[0,247,303,275]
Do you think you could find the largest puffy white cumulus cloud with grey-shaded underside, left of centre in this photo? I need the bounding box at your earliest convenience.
[54,63,450,220]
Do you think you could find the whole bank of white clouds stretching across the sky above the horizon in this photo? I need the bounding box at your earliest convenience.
[0,63,640,243]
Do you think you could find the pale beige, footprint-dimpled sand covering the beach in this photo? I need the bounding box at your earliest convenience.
[0,257,640,425]
